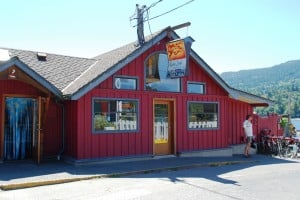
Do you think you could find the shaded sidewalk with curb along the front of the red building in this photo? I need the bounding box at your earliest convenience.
[0,155,266,190]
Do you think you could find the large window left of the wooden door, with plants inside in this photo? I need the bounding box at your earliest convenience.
[93,99,138,132]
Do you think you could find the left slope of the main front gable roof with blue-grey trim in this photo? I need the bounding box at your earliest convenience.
[63,28,167,100]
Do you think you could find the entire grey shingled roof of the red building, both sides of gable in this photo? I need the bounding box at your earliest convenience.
[0,27,274,106]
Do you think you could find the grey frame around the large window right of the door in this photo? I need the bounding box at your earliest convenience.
[186,101,221,131]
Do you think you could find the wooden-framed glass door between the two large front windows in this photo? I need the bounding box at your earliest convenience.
[153,100,175,155]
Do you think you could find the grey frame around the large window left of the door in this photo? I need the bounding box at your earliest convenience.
[91,97,140,134]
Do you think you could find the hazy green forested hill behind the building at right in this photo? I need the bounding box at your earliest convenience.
[220,60,300,117]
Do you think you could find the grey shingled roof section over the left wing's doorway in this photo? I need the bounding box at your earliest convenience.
[0,48,96,96]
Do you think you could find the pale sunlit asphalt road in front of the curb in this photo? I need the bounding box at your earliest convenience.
[0,160,300,200]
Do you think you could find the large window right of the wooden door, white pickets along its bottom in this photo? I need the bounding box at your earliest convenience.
[188,102,219,129]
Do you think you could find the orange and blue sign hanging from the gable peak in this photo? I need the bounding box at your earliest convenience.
[166,39,191,78]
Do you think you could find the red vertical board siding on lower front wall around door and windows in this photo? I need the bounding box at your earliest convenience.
[73,89,241,159]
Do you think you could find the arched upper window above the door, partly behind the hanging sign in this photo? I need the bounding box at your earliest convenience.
[145,53,181,92]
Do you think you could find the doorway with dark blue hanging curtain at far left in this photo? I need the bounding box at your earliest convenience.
[3,97,38,160]
